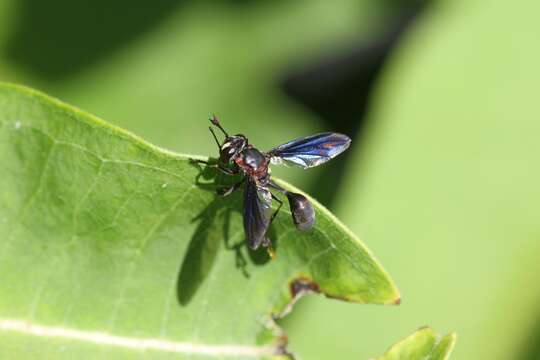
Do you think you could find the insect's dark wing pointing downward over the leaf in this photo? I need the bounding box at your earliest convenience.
[244,179,272,249]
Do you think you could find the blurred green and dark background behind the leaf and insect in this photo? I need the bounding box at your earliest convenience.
[0,0,540,359]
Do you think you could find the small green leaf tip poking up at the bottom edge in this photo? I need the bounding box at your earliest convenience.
[377,327,456,360]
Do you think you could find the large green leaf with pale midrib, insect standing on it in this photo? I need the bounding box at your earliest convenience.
[0,84,399,359]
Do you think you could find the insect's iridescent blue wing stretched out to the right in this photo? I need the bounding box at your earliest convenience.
[268,133,351,169]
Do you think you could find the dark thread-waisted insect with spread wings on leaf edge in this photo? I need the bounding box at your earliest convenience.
[199,115,351,255]
